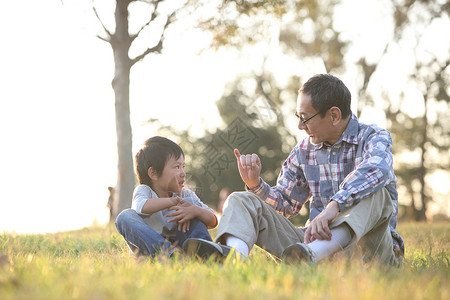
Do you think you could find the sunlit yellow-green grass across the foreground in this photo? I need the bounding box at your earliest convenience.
[0,223,450,300]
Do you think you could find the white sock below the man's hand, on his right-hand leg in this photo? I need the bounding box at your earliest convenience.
[308,224,352,261]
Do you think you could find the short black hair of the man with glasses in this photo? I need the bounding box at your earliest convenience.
[298,74,352,119]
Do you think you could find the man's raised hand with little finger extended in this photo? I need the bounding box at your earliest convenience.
[234,149,262,189]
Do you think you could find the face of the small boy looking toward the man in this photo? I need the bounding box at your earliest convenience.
[149,155,186,198]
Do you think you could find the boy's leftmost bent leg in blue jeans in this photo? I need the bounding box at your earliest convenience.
[115,209,171,256]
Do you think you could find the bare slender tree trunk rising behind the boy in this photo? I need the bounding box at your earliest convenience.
[111,0,135,220]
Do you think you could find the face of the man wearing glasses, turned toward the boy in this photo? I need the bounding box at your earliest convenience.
[296,93,335,145]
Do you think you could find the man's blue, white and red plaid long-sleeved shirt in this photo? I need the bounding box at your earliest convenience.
[249,115,404,251]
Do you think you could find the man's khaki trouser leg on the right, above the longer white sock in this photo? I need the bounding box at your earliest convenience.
[330,188,395,264]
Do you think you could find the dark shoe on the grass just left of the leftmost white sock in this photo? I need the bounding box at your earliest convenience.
[183,238,231,259]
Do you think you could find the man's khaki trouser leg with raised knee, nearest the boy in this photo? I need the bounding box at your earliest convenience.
[216,192,304,257]
